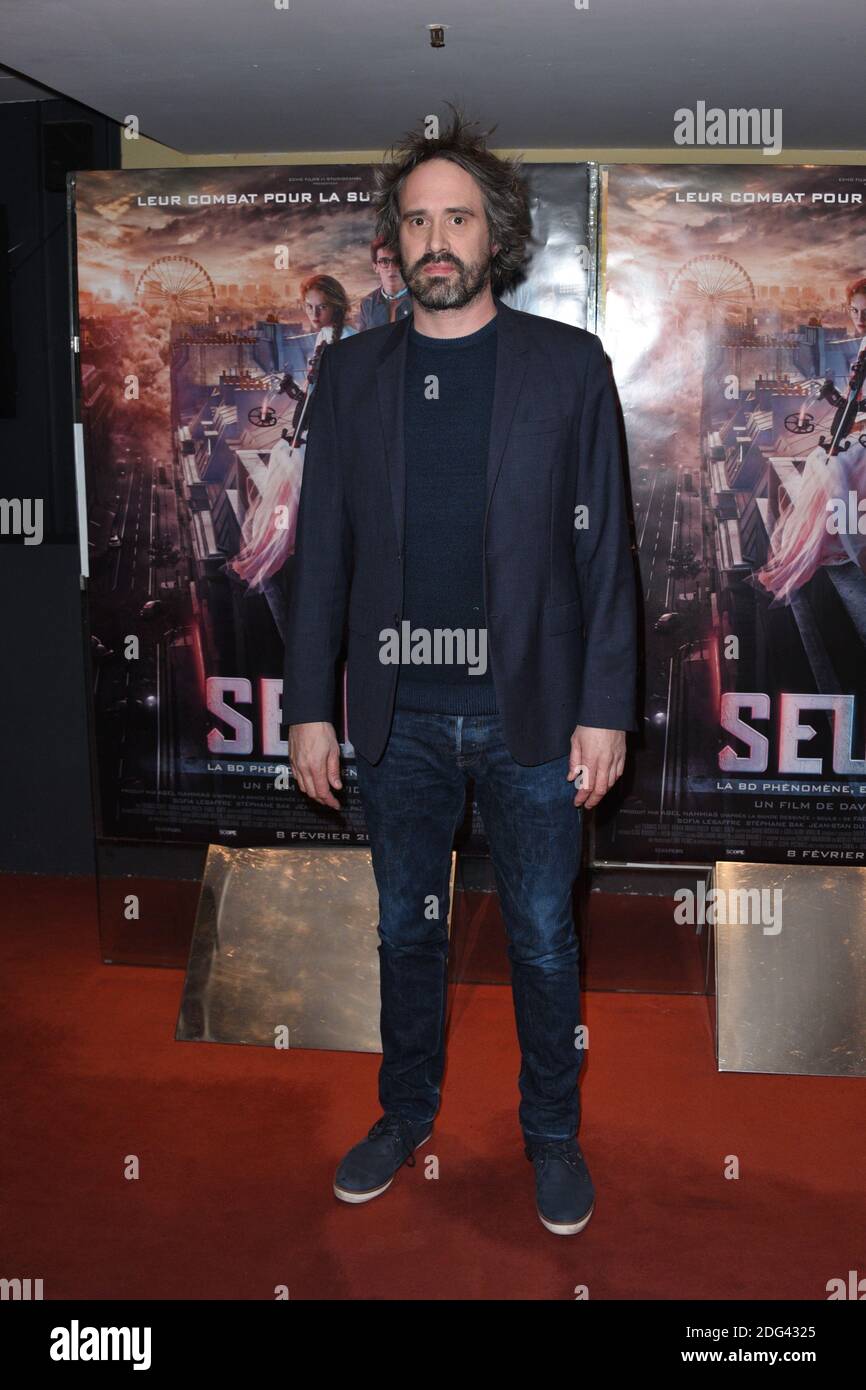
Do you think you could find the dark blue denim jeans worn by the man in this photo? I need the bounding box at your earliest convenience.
[356,709,584,1140]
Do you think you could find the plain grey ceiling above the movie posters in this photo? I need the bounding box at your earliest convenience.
[0,0,866,153]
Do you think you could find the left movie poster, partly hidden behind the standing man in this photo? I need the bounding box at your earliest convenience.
[72,164,596,851]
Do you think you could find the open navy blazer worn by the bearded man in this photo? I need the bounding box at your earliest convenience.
[282,299,638,765]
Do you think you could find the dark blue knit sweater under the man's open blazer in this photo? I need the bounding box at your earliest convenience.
[396,309,496,714]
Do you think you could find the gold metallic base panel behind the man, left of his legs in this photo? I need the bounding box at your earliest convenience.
[175,845,456,1052]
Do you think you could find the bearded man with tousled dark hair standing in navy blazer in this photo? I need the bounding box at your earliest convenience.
[284,113,637,1234]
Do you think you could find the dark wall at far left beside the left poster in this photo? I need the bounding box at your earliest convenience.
[0,99,120,874]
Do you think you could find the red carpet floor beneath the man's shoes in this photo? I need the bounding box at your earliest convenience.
[0,878,866,1300]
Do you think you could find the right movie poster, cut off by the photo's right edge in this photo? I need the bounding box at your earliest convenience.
[596,165,866,865]
